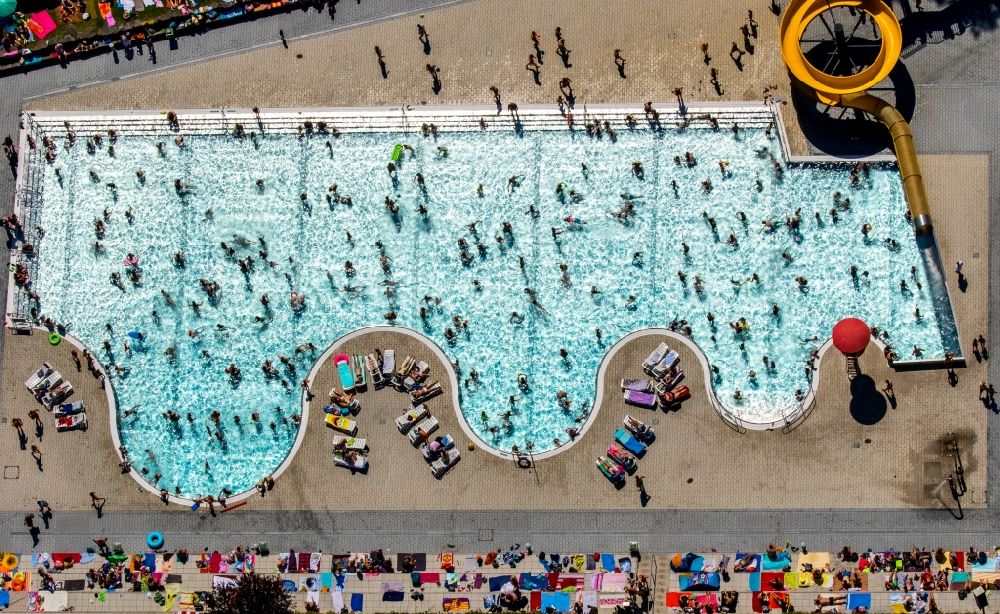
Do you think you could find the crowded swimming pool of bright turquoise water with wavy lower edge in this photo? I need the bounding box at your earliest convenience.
[11,112,956,495]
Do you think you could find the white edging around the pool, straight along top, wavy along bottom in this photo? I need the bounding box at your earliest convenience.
[7,106,954,496]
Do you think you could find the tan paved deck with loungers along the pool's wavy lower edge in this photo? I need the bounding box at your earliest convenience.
[0,156,988,511]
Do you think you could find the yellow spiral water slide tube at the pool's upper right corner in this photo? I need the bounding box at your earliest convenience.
[778,0,933,234]
